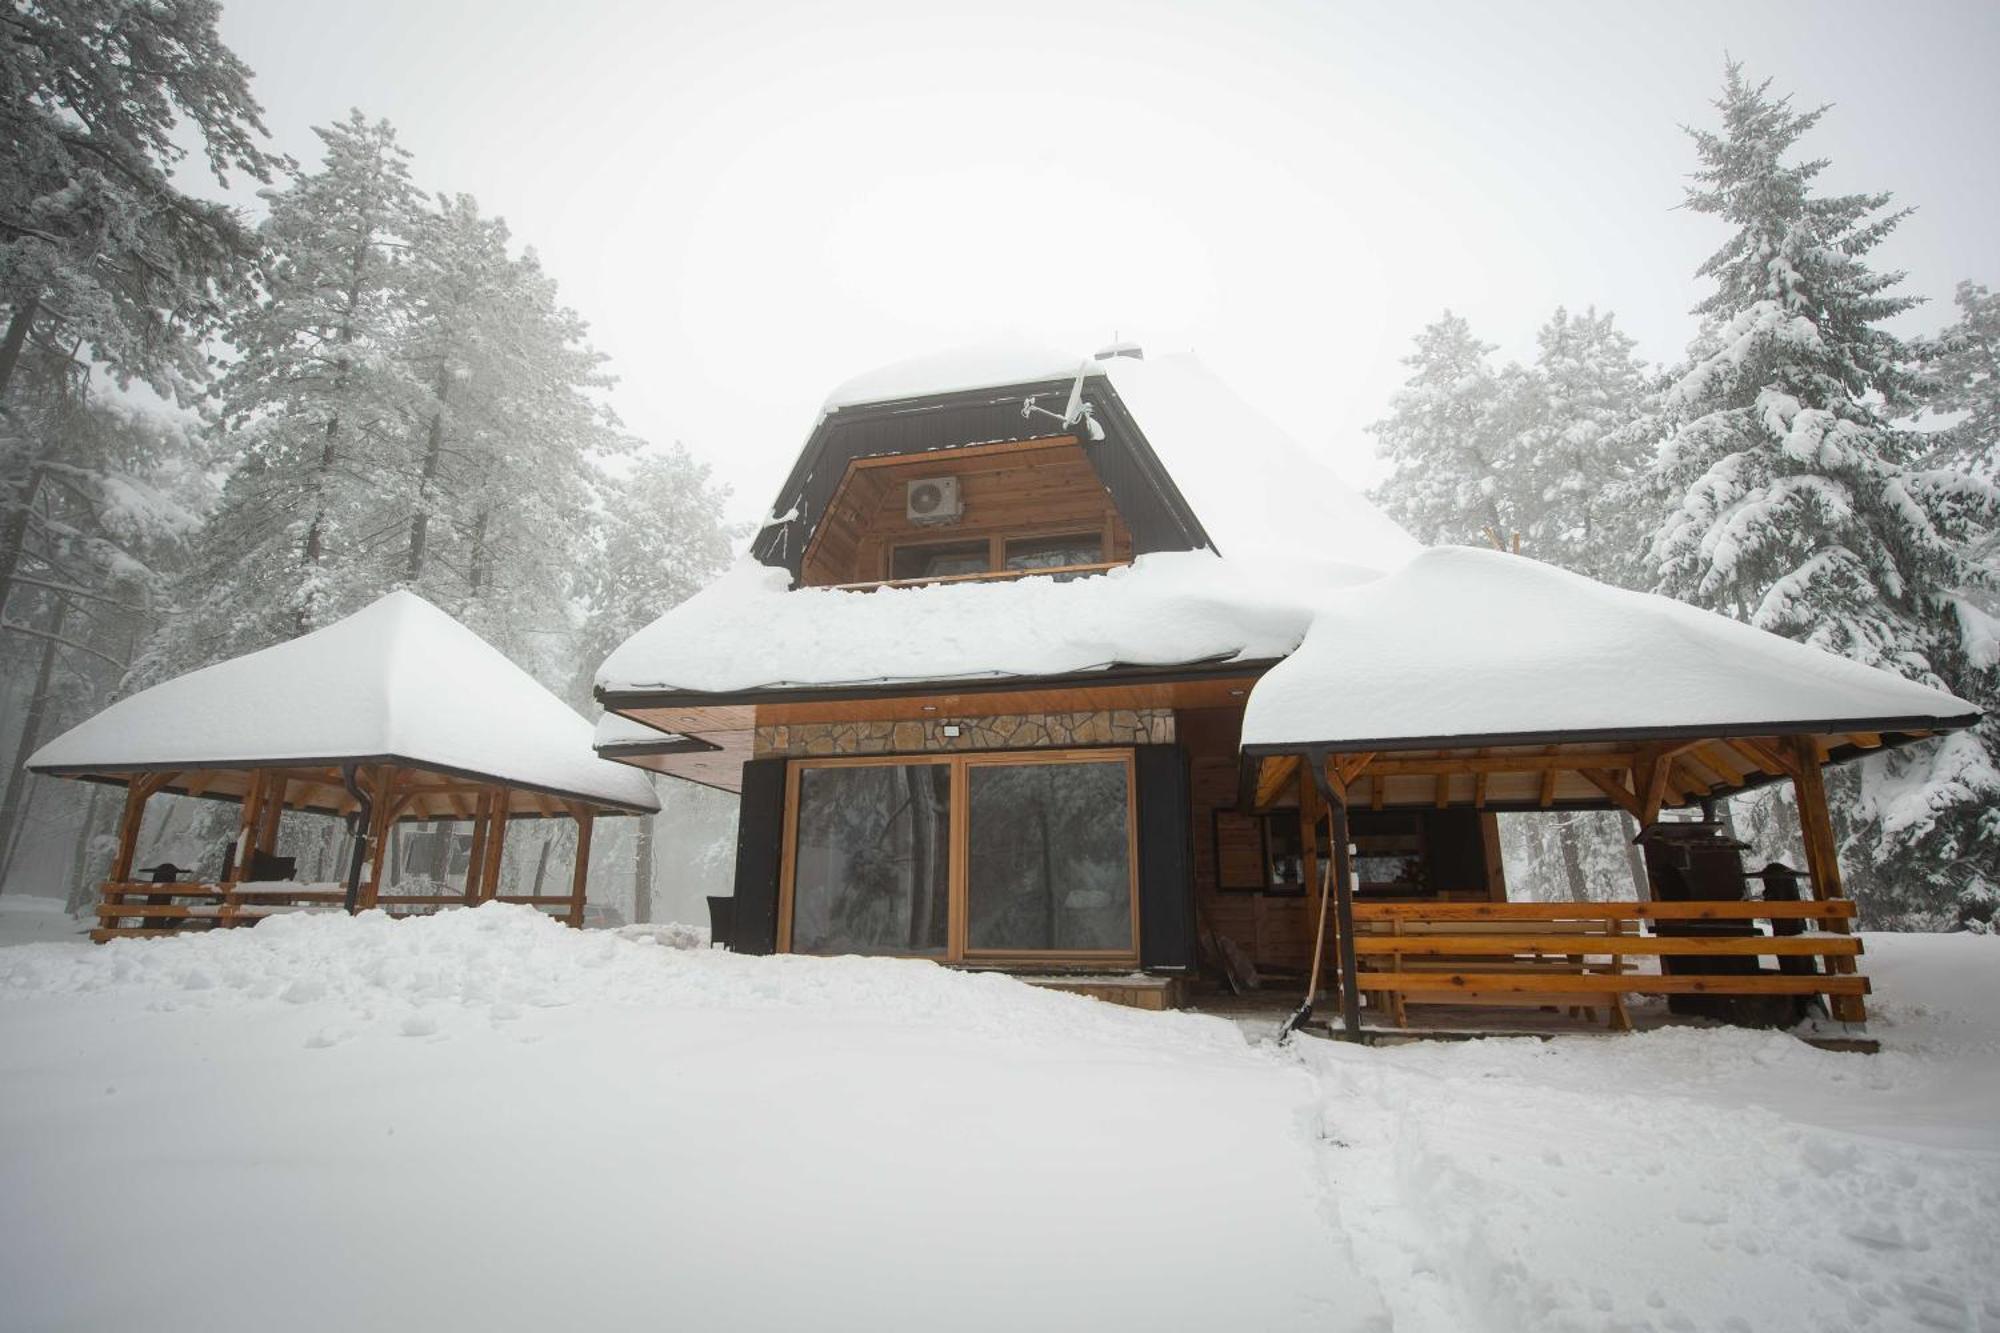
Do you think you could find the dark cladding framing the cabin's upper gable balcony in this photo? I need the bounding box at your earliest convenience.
[750,376,1210,582]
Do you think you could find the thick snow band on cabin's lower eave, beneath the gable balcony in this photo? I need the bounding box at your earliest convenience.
[598,550,1308,693]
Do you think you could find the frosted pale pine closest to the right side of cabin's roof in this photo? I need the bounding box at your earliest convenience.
[1368,310,1538,544]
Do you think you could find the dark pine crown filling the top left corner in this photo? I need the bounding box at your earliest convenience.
[0,0,274,402]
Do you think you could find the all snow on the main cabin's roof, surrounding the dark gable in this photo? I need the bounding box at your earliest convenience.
[598,344,1422,695]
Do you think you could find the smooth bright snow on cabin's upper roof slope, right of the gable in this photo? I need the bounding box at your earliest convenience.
[1104,354,1422,596]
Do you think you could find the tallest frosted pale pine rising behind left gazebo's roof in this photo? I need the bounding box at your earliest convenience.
[146,112,422,677]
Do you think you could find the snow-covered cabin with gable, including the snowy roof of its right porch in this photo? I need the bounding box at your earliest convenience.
[598,346,1974,1024]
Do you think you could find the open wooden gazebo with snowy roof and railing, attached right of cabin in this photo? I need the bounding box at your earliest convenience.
[1242,546,1980,1033]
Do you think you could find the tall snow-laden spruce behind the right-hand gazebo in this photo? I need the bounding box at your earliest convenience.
[1650,64,2000,913]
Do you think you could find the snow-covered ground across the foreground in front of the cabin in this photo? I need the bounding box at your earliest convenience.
[0,899,2000,1333]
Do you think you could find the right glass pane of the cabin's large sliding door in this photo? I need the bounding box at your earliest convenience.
[966,759,1132,953]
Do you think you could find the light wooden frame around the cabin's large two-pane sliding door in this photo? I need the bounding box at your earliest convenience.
[778,747,1140,971]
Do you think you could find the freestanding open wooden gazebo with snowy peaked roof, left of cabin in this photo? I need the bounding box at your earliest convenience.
[28,590,660,941]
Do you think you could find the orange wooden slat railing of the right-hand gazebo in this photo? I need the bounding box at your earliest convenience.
[1354,899,1868,1027]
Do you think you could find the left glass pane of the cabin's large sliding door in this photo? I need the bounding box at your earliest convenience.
[792,763,952,955]
